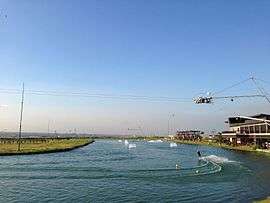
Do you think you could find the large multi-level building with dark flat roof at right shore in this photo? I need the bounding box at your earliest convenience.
[221,114,270,147]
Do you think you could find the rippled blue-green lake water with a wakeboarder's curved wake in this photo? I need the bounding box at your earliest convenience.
[0,140,270,202]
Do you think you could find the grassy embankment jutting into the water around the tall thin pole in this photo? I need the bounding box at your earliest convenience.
[0,137,93,156]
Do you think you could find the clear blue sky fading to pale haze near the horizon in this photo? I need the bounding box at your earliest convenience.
[0,0,270,134]
